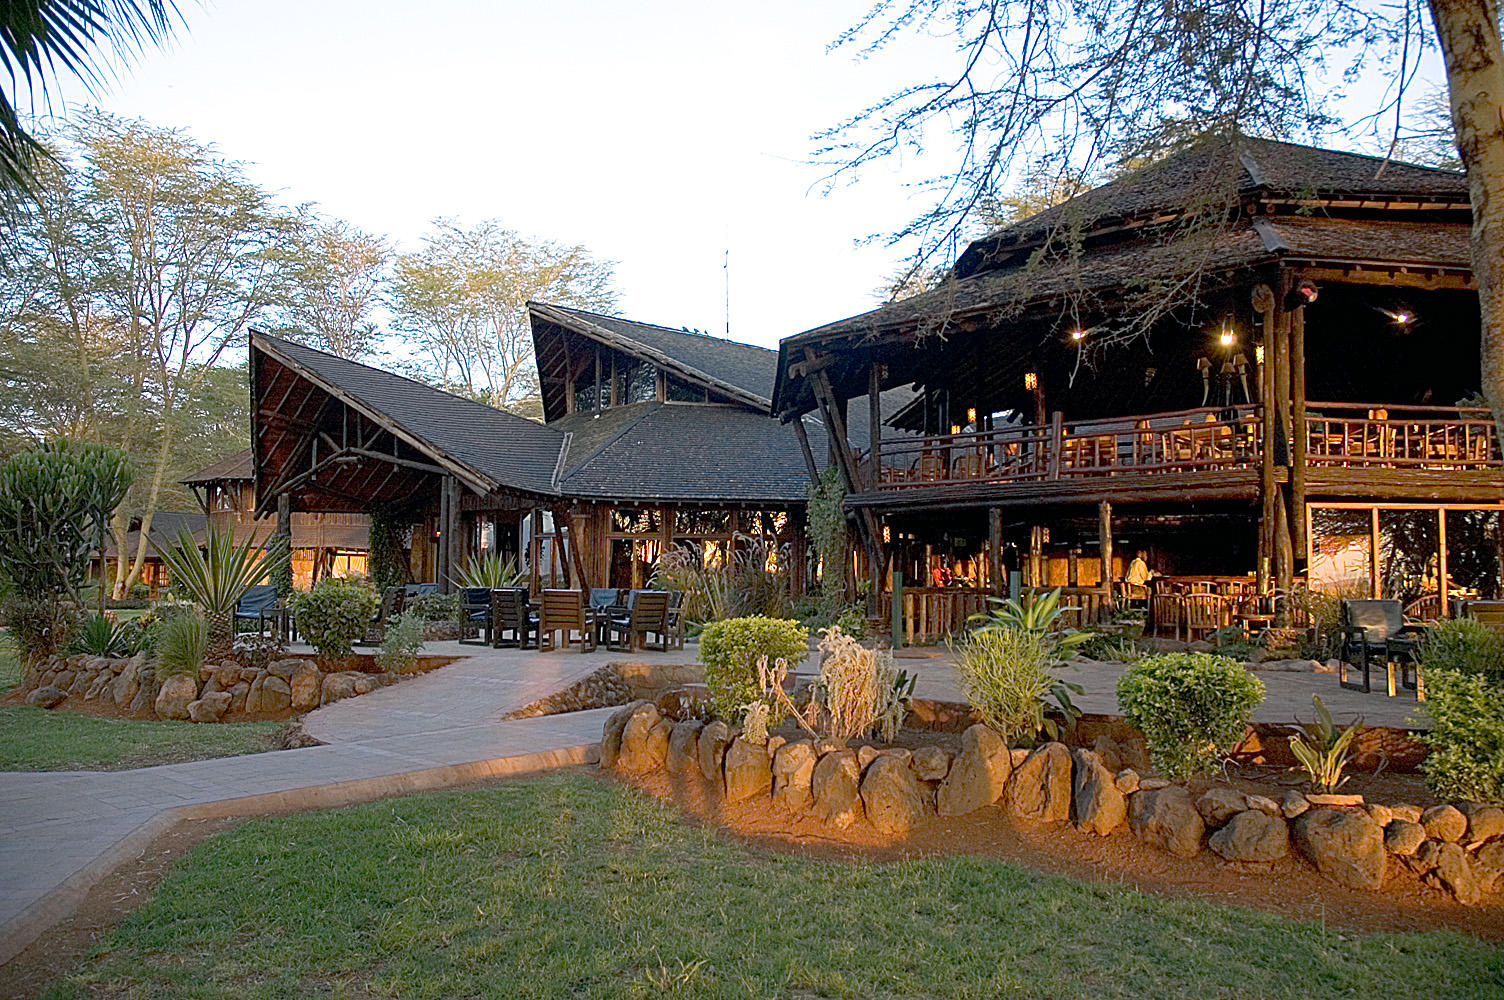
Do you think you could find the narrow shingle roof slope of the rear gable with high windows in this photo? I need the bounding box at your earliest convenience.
[528,302,778,406]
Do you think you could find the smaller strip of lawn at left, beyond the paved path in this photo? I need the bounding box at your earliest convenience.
[0,705,287,771]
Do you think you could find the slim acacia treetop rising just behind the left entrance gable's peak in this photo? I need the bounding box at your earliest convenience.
[273,214,391,361]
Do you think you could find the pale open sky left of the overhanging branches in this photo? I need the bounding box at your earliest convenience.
[41,0,954,346]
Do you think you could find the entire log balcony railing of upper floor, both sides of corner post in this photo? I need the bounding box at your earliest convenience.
[875,403,1504,490]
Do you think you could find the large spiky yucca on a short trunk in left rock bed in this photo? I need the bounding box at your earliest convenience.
[161,522,289,660]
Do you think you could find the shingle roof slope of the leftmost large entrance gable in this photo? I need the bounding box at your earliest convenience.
[257,334,564,495]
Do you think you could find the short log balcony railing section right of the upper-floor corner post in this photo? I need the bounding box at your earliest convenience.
[1305,403,1504,469]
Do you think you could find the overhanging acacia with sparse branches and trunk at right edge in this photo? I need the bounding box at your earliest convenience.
[817,0,1504,433]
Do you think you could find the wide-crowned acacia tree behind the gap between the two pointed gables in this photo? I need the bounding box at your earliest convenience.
[391,218,617,409]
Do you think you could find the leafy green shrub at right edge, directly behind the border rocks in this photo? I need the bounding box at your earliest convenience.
[1421,669,1504,803]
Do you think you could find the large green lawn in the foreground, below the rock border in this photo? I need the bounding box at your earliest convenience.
[42,773,1504,1000]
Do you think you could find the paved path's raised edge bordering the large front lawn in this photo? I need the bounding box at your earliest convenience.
[0,744,600,965]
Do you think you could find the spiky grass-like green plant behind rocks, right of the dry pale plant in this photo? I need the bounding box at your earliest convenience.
[955,629,1054,743]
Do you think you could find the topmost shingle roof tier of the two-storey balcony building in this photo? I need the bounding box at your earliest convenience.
[957,135,1468,277]
